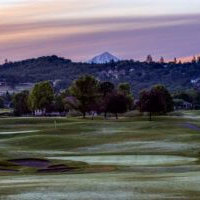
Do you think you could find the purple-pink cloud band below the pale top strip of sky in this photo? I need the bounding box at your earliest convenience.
[0,15,200,61]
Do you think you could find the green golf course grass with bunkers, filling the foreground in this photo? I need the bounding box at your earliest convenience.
[0,111,200,200]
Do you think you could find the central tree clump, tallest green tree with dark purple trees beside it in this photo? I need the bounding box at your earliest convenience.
[69,75,133,118]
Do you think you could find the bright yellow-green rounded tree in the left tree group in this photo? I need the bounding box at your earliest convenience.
[29,81,54,112]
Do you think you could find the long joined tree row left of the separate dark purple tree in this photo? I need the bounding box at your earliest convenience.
[13,75,133,118]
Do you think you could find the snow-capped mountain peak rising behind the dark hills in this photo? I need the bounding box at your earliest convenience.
[88,52,120,64]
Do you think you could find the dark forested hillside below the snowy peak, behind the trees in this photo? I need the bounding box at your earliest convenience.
[0,56,200,92]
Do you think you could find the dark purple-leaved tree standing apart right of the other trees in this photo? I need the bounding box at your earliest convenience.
[139,85,173,121]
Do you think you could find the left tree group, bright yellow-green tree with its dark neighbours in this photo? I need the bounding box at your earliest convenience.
[13,81,62,116]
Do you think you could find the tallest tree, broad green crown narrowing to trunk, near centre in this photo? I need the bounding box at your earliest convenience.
[69,75,99,118]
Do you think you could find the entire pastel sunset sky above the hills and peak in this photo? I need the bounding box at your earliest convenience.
[0,0,200,63]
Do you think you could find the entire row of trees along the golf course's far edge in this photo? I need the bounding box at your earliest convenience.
[13,75,173,120]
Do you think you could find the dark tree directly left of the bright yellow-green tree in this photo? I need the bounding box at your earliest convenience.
[13,91,30,116]
